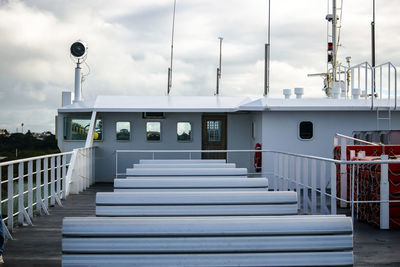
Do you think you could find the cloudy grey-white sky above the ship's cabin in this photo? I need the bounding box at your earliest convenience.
[0,0,400,132]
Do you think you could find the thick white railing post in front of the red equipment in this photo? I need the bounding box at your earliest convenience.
[380,155,389,229]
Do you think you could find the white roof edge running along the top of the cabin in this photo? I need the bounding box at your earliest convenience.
[57,96,398,113]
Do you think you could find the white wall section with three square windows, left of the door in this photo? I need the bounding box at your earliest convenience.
[96,113,201,182]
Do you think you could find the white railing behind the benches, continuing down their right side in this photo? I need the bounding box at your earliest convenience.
[116,149,400,229]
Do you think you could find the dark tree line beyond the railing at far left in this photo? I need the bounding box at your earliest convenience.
[0,130,60,161]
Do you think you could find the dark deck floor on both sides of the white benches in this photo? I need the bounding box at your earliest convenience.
[3,184,400,266]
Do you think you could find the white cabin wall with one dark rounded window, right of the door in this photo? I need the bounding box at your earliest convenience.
[262,111,400,175]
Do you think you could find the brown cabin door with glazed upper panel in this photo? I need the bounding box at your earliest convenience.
[201,115,226,159]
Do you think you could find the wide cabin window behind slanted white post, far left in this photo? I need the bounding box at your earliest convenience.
[64,117,103,140]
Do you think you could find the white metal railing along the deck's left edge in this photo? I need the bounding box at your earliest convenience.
[0,148,94,238]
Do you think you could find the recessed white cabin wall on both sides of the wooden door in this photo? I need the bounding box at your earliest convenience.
[57,112,253,182]
